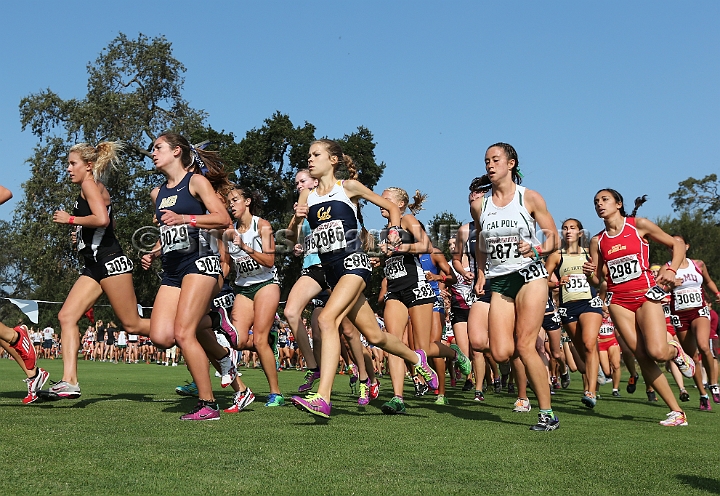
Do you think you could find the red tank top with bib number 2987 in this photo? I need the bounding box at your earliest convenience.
[598,217,655,293]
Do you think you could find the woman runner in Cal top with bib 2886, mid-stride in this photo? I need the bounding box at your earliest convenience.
[290,139,437,418]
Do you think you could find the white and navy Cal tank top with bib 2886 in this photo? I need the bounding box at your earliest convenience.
[307,181,362,265]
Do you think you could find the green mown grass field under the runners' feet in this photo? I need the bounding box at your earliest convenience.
[0,360,720,495]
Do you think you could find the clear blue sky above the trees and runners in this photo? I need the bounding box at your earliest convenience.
[0,1,720,232]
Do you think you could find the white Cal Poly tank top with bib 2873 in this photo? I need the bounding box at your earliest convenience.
[480,185,540,279]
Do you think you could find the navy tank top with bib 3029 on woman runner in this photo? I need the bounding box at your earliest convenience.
[155,172,206,266]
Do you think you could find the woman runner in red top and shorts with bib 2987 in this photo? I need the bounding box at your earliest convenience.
[583,189,695,427]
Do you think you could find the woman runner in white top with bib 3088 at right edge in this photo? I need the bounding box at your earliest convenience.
[670,235,720,411]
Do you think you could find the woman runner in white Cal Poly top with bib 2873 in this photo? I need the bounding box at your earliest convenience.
[471,143,560,431]
